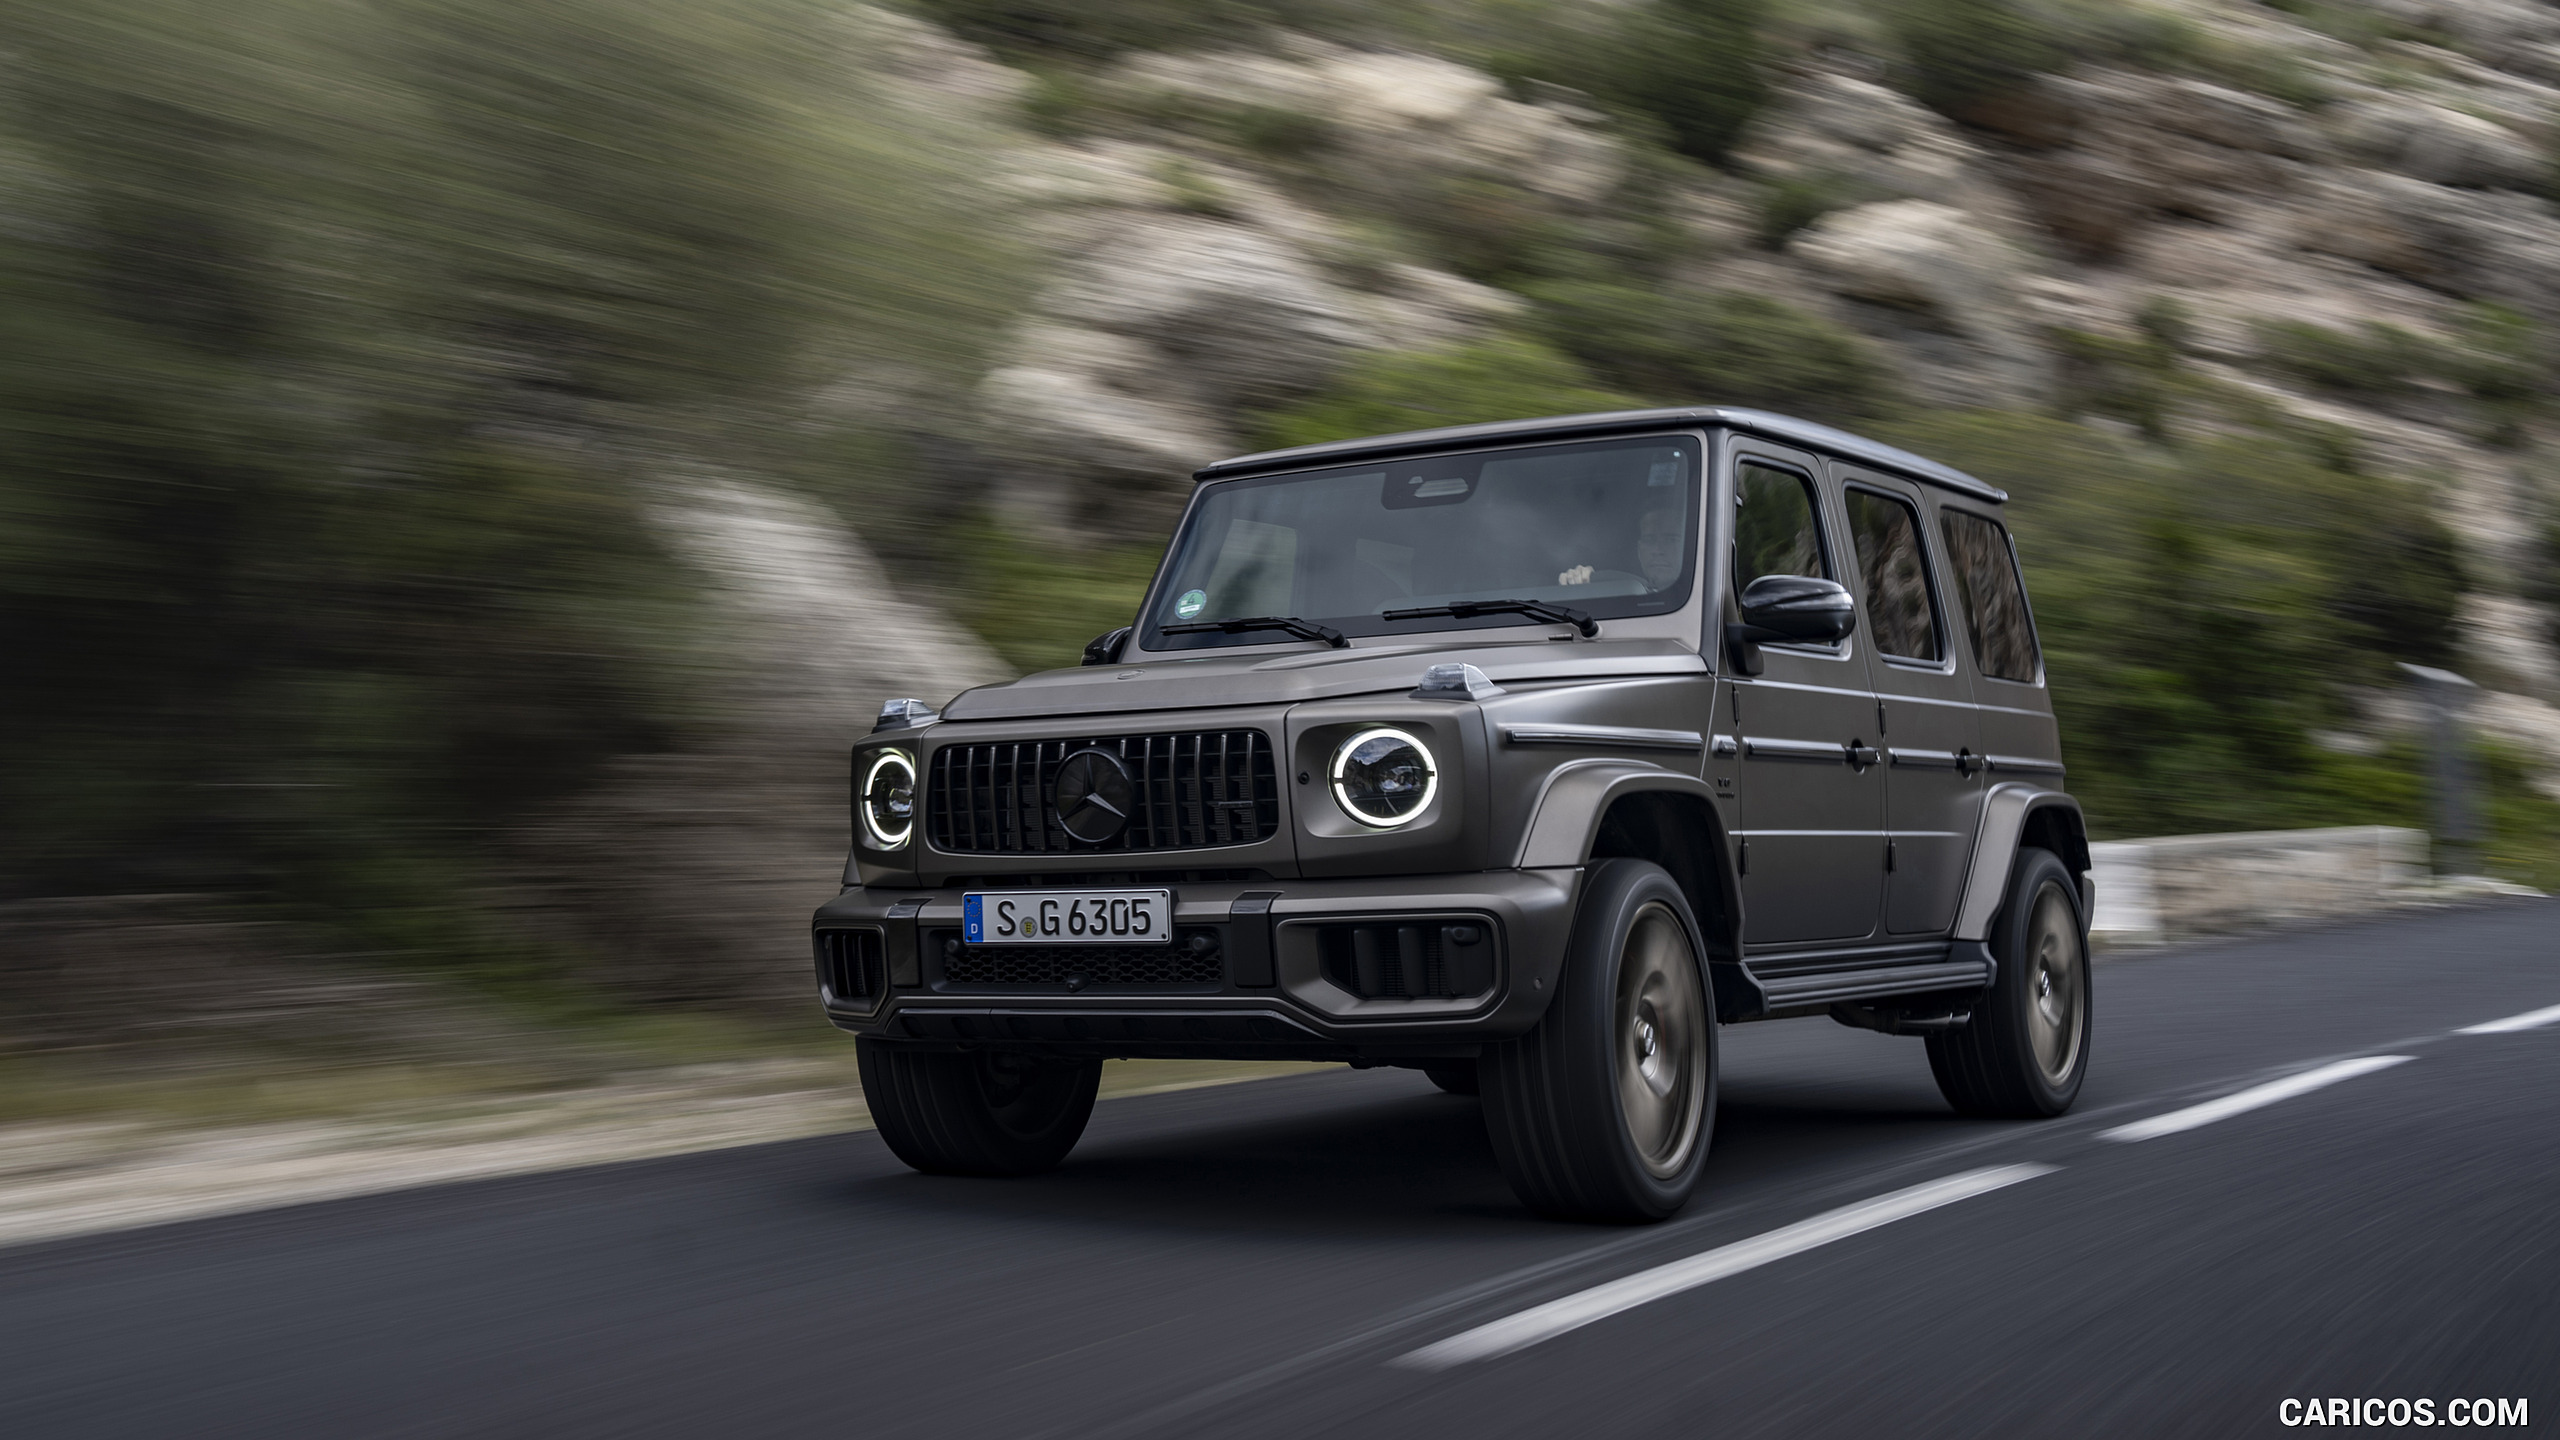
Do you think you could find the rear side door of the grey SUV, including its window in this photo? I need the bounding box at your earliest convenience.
[1836,464,1981,935]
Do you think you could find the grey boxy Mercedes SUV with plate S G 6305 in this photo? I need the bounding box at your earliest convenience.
[814,407,2092,1220]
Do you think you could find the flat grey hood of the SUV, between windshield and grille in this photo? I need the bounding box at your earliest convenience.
[942,635,1708,720]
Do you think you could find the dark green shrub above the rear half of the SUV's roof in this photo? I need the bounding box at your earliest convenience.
[1523,282,1897,420]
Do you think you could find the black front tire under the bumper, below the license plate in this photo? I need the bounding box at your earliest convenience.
[855,1040,1103,1176]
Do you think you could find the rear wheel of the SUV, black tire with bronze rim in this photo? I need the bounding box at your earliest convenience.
[1928,848,2094,1120]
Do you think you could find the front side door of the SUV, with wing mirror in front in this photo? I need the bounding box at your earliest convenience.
[1728,441,1884,945]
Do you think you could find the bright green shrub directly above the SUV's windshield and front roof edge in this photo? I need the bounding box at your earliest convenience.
[1254,338,1633,448]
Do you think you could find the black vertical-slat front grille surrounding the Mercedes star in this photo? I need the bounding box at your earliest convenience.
[924,730,1280,856]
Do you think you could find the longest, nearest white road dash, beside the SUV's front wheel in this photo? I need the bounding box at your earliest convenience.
[1388,1166,2061,1371]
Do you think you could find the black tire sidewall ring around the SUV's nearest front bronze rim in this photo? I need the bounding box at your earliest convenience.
[1554,858,1720,1220]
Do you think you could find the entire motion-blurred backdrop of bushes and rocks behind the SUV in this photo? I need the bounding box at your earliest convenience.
[0,0,2560,1142]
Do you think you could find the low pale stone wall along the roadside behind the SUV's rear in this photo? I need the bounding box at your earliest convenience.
[2089,825,2426,945]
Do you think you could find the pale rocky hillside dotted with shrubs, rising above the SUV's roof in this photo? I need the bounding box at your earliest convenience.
[878,0,2560,784]
